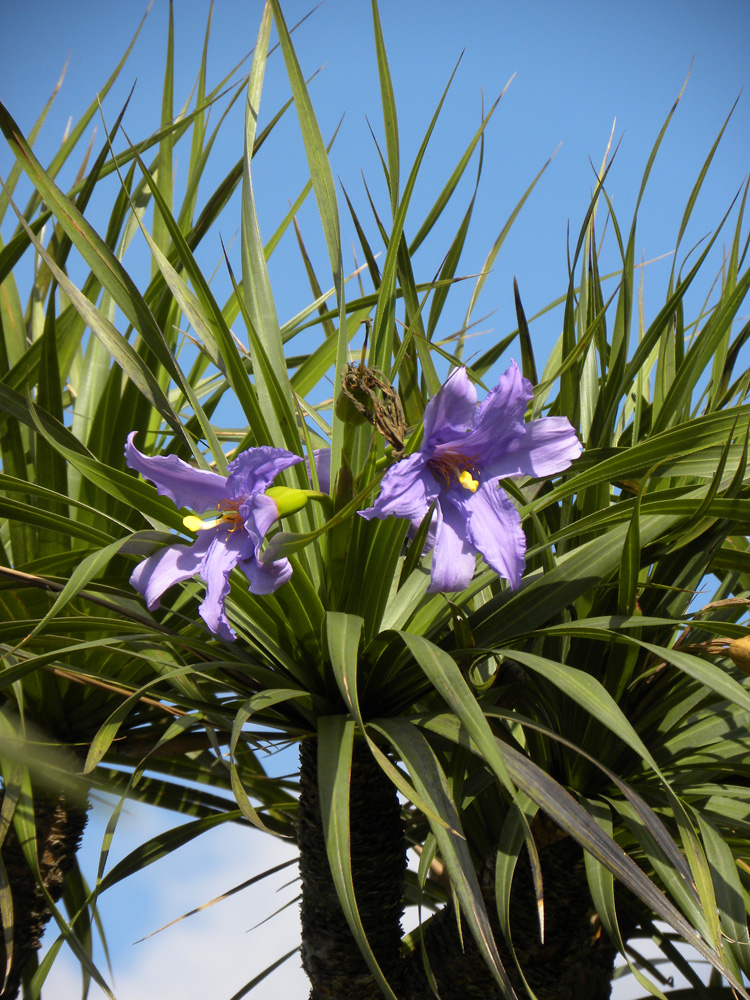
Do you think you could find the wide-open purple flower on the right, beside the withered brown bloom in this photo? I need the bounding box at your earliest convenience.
[359,361,583,593]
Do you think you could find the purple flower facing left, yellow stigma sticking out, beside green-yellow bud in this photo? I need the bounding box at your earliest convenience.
[125,432,306,640]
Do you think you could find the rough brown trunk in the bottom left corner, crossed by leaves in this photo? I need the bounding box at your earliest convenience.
[0,790,87,1000]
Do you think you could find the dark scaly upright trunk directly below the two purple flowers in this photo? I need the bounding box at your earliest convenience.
[298,739,406,1000]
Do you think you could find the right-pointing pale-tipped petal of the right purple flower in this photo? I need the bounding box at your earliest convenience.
[485,417,583,478]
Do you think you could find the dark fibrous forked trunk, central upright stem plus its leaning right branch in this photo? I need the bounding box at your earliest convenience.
[298,740,616,1000]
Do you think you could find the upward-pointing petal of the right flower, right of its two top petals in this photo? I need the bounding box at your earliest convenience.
[461,361,534,466]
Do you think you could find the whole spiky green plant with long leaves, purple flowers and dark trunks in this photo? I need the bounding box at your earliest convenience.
[0,0,750,1000]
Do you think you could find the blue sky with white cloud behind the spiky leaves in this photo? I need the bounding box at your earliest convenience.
[0,0,750,1000]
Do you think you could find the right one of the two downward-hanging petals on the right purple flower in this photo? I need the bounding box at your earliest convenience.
[465,480,526,589]
